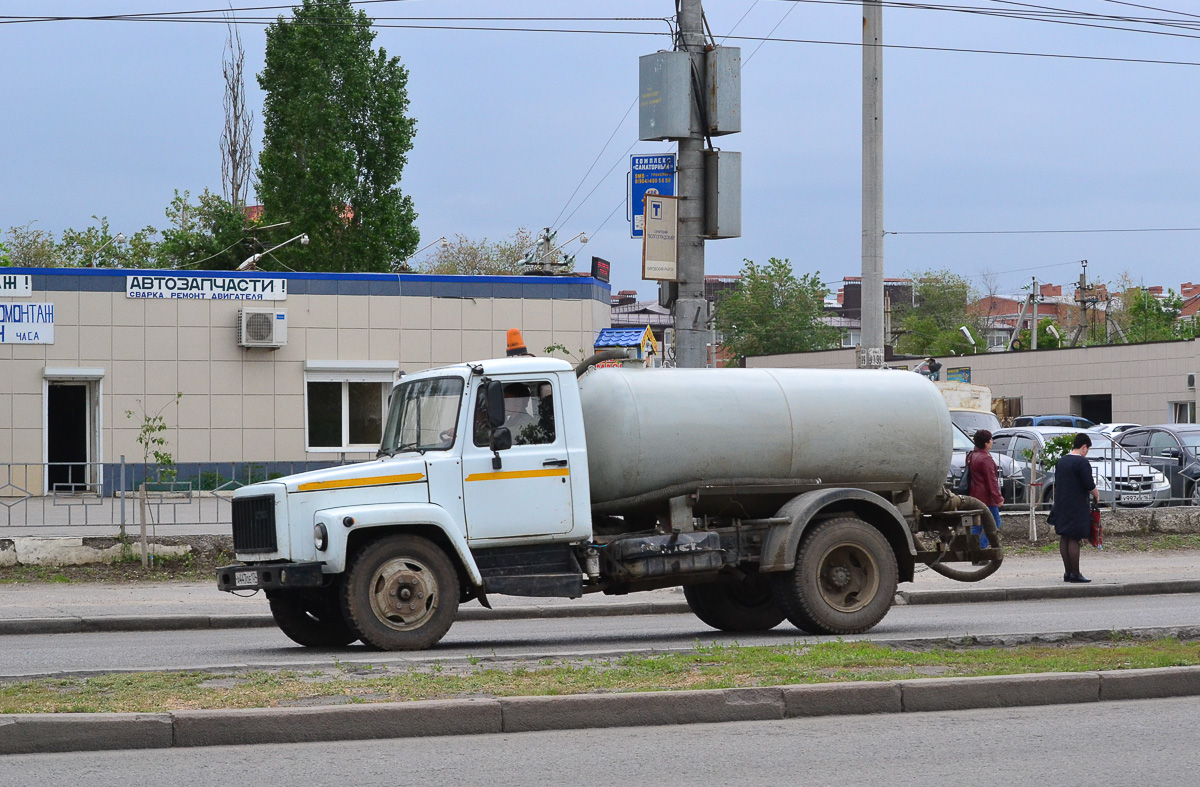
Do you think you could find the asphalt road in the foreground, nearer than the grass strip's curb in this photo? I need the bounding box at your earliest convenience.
[0,697,1200,787]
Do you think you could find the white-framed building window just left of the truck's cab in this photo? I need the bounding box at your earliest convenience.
[305,361,394,451]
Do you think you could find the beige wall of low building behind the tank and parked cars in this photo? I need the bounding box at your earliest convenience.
[746,340,1200,423]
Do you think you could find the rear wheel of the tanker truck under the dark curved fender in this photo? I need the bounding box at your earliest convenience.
[774,516,899,635]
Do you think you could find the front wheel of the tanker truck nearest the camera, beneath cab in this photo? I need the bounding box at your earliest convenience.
[342,535,460,650]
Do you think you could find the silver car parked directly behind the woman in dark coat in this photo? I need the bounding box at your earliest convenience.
[992,426,1171,507]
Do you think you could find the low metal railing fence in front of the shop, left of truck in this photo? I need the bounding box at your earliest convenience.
[0,457,346,535]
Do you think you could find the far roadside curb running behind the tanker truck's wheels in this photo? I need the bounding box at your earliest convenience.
[0,579,1200,636]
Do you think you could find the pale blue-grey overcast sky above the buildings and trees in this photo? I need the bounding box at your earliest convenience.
[0,0,1200,299]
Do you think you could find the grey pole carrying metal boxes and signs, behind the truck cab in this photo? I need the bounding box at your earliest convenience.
[664,0,708,368]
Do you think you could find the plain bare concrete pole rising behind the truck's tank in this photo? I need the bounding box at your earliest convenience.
[858,0,886,366]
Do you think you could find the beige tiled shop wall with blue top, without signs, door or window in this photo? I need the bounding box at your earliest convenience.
[0,269,610,467]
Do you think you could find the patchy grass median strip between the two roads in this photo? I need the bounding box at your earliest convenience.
[0,635,1200,714]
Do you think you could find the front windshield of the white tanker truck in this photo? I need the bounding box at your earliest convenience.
[379,377,463,456]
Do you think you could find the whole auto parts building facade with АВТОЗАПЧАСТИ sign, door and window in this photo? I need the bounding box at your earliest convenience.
[0,269,610,493]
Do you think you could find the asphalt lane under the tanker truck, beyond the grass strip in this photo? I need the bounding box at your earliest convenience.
[0,594,1200,677]
